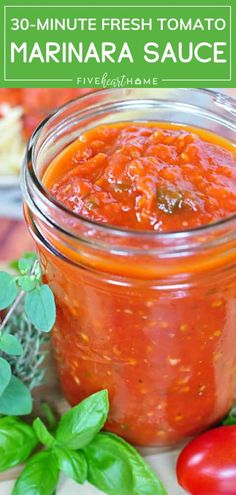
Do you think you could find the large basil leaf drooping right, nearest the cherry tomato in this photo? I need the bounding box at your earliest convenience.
[83,433,167,495]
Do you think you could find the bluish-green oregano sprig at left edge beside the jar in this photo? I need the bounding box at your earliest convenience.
[0,252,56,415]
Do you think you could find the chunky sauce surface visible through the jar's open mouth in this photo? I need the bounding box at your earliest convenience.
[46,123,236,232]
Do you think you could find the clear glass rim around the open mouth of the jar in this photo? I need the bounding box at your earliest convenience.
[21,88,236,244]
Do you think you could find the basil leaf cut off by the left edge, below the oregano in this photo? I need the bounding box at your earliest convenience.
[0,416,38,471]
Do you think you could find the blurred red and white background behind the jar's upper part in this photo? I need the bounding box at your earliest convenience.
[0,88,236,264]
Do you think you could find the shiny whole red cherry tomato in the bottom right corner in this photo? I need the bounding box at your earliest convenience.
[177,426,236,495]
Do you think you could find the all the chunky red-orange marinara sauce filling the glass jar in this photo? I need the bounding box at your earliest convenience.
[41,122,236,446]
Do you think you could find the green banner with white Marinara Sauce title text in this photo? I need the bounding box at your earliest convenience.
[1,0,236,88]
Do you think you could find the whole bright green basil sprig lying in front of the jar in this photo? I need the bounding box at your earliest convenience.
[0,390,167,495]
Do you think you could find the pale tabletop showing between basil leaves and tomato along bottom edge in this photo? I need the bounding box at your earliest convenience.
[0,451,186,495]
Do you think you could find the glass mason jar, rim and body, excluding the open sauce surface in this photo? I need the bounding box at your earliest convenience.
[22,89,236,447]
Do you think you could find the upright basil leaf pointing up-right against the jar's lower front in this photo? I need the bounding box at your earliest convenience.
[56,390,109,450]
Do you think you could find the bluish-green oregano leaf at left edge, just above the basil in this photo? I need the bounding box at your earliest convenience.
[0,375,32,416]
